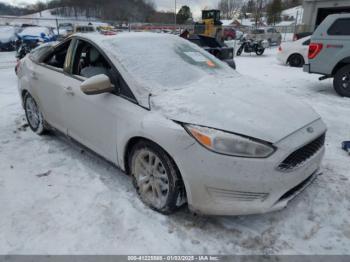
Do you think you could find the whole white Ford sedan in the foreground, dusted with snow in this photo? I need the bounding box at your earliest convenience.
[16,33,326,215]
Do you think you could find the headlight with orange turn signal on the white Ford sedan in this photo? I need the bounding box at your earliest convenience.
[184,124,275,158]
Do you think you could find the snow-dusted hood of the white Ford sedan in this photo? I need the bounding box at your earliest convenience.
[150,76,320,143]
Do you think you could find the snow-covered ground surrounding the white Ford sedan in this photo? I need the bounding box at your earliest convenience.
[0,49,350,254]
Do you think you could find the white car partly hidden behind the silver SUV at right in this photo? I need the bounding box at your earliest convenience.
[277,36,311,67]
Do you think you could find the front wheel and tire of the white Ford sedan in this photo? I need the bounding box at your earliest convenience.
[128,140,184,215]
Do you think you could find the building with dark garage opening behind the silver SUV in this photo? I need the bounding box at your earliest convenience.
[303,0,350,32]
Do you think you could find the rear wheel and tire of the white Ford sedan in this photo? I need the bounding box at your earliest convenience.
[24,93,47,135]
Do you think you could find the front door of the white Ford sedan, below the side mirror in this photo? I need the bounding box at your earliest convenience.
[63,40,121,162]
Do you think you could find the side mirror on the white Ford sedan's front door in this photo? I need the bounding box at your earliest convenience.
[80,74,113,95]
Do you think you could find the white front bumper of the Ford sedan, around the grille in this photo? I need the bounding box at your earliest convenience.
[177,120,326,215]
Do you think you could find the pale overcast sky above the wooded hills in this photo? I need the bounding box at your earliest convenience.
[0,0,219,17]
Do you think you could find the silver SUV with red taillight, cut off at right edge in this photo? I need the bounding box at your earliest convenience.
[304,14,350,97]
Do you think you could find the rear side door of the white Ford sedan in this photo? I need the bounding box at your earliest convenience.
[30,40,75,133]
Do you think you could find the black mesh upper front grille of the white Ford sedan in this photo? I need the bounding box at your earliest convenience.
[278,134,326,171]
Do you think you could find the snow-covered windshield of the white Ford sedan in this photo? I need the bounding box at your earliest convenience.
[103,33,235,91]
